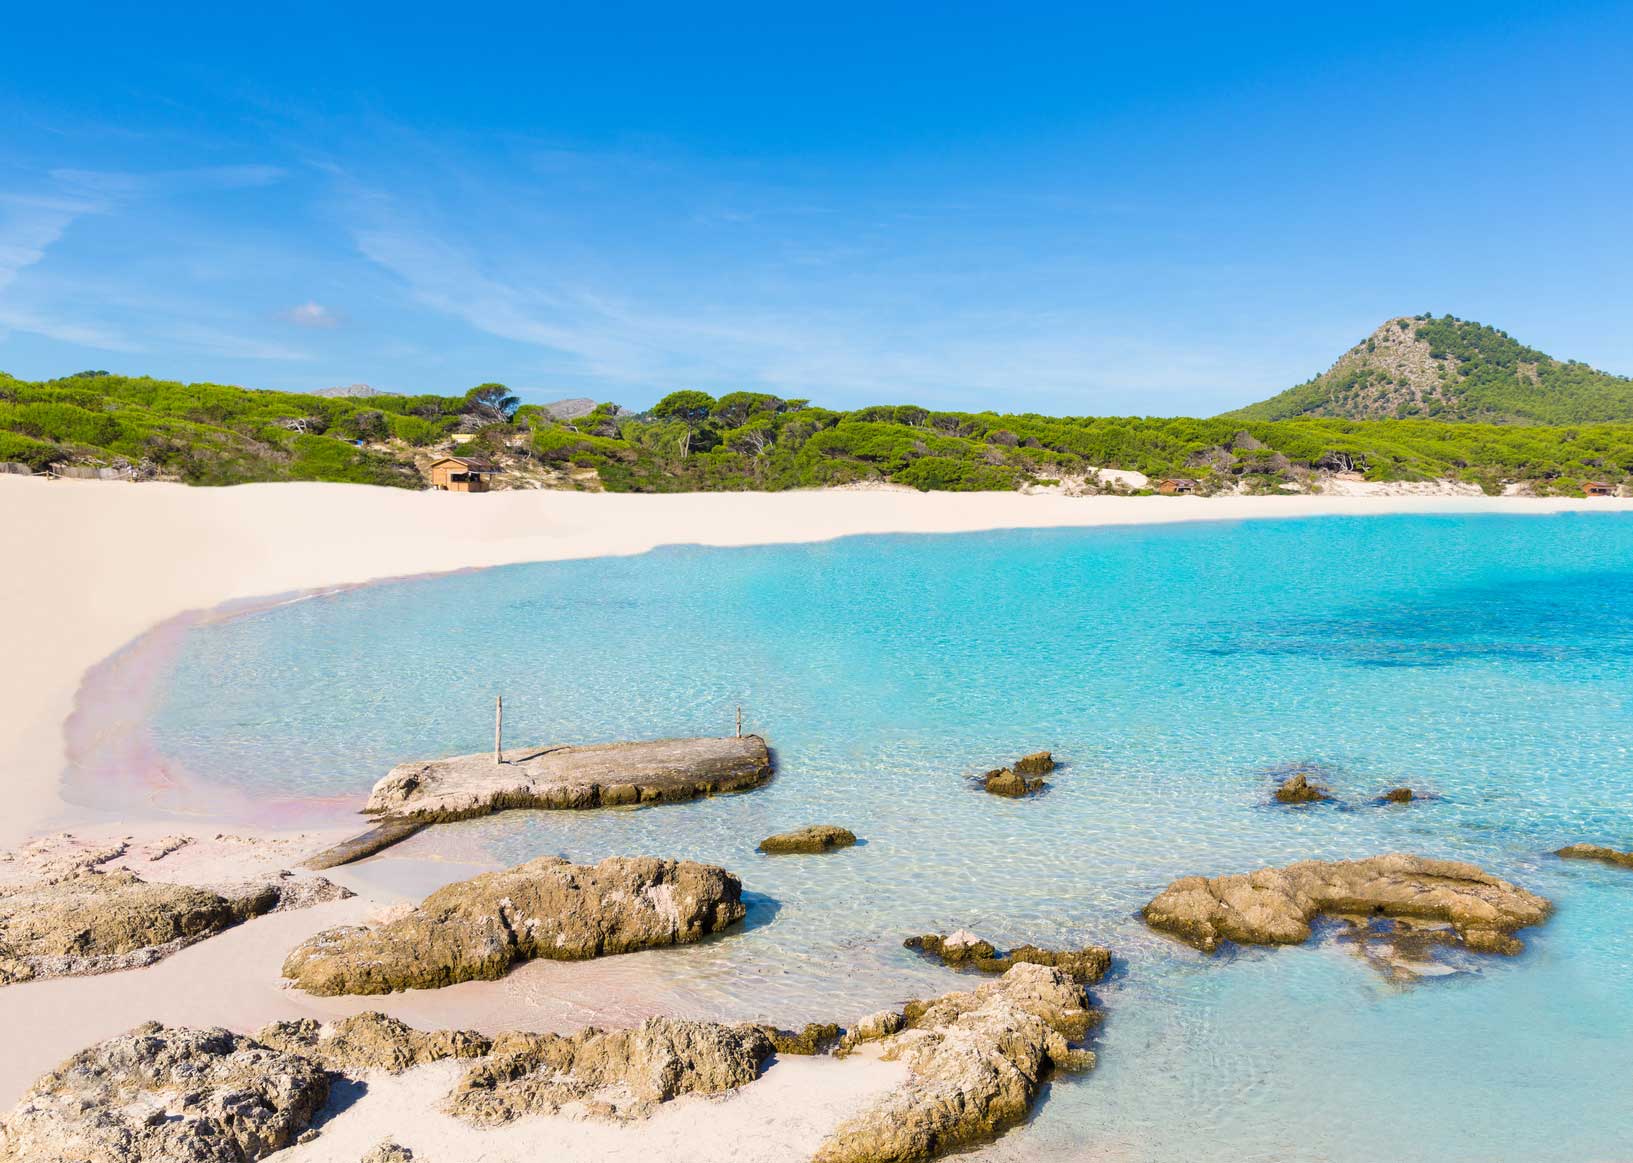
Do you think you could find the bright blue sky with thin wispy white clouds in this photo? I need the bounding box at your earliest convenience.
[0,3,1633,415]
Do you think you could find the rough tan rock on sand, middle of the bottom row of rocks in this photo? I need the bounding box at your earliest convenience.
[447,1018,774,1127]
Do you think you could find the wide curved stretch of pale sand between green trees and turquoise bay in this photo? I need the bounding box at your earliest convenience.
[0,477,1633,848]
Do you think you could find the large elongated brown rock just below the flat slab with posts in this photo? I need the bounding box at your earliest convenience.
[284,856,745,995]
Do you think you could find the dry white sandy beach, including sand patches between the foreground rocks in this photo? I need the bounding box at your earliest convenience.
[0,477,1633,1160]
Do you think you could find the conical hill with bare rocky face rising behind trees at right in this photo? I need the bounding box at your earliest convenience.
[1225,315,1633,425]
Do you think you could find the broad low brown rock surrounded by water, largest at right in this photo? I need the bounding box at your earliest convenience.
[1141,853,1550,954]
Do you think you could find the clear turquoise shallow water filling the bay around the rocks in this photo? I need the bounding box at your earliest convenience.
[137,515,1633,1161]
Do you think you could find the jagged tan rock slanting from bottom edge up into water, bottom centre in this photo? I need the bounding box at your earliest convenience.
[815,965,1097,1163]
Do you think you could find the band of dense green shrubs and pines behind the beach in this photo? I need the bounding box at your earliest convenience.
[0,372,1633,493]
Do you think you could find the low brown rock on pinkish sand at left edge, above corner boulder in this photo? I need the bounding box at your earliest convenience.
[0,869,351,985]
